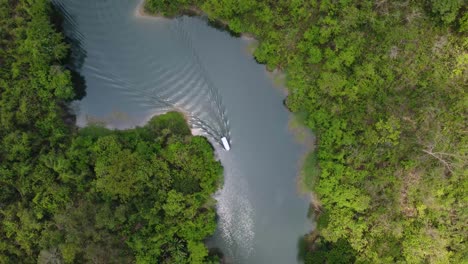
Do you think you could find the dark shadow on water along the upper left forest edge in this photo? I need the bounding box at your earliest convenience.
[51,1,86,100]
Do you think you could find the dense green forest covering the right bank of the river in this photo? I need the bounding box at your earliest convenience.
[145,0,468,263]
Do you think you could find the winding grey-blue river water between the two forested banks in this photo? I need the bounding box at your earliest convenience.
[54,0,311,264]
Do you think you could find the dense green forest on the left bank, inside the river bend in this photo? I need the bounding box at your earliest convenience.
[0,0,222,263]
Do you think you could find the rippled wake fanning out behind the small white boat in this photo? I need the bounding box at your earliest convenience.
[54,0,231,150]
